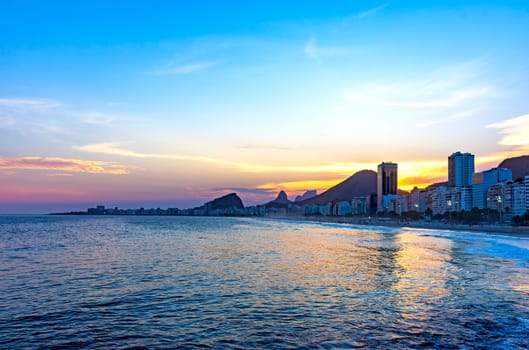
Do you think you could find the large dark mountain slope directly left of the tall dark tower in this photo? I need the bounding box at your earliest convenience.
[296,170,377,205]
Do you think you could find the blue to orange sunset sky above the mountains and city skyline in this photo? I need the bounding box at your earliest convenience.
[0,0,529,213]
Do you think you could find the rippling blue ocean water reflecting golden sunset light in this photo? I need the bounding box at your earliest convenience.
[0,216,529,349]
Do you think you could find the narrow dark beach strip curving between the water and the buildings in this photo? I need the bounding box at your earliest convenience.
[264,215,529,238]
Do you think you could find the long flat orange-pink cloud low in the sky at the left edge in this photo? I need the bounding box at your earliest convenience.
[0,157,129,175]
